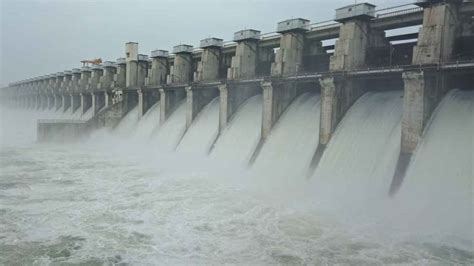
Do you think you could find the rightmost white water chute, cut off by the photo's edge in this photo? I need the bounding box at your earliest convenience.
[397,90,474,240]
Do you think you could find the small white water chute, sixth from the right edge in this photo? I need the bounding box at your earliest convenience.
[152,101,186,152]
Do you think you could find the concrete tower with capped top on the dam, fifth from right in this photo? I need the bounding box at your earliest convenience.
[194,38,223,81]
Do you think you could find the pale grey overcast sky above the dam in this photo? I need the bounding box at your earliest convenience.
[0,0,413,85]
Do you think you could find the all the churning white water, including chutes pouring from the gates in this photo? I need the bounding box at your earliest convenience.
[0,91,474,265]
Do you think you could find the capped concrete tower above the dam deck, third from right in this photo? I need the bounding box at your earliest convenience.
[271,18,309,76]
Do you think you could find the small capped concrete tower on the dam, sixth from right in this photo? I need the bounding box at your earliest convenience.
[167,44,193,84]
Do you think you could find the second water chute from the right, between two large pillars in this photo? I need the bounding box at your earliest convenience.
[312,91,402,205]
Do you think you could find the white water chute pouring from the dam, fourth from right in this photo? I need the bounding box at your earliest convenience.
[211,95,262,165]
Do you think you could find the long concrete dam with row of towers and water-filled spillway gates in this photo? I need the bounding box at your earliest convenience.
[0,0,474,195]
